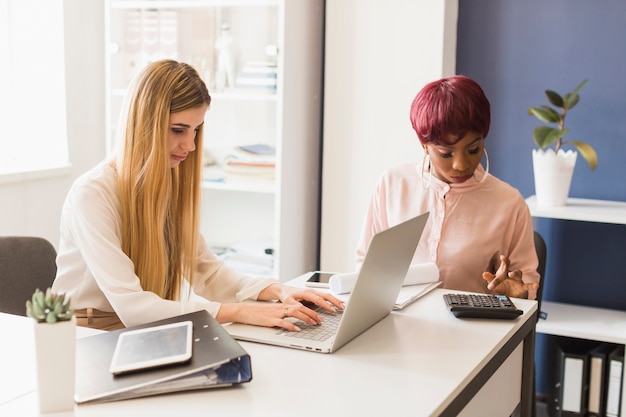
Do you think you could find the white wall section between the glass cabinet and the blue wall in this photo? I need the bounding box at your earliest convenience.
[320,0,458,272]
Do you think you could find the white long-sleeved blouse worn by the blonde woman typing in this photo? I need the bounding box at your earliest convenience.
[57,172,269,326]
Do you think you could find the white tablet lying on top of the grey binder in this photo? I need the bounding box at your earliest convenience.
[110,321,193,375]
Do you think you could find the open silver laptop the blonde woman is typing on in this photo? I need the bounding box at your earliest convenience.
[225,212,429,353]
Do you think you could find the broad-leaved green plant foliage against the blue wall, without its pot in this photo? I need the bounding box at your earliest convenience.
[528,79,598,170]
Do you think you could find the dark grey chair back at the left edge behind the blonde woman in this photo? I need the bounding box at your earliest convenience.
[0,236,57,316]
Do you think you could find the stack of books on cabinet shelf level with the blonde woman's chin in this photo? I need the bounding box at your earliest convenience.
[224,144,276,182]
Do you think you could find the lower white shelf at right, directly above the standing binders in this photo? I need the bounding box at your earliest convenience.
[536,301,626,345]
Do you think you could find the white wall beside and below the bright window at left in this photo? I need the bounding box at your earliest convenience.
[0,0,105,247]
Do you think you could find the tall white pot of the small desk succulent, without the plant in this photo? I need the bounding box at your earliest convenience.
[34,317,76,413]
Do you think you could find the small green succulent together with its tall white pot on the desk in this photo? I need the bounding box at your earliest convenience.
[26,288,76,413]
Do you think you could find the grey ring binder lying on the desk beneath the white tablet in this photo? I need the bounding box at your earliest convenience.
[75,310,252,404]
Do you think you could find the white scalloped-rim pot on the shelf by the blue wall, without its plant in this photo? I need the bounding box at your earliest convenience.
[533,149,578,207]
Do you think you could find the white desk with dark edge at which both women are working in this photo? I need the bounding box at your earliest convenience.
[0,289,537,417]
